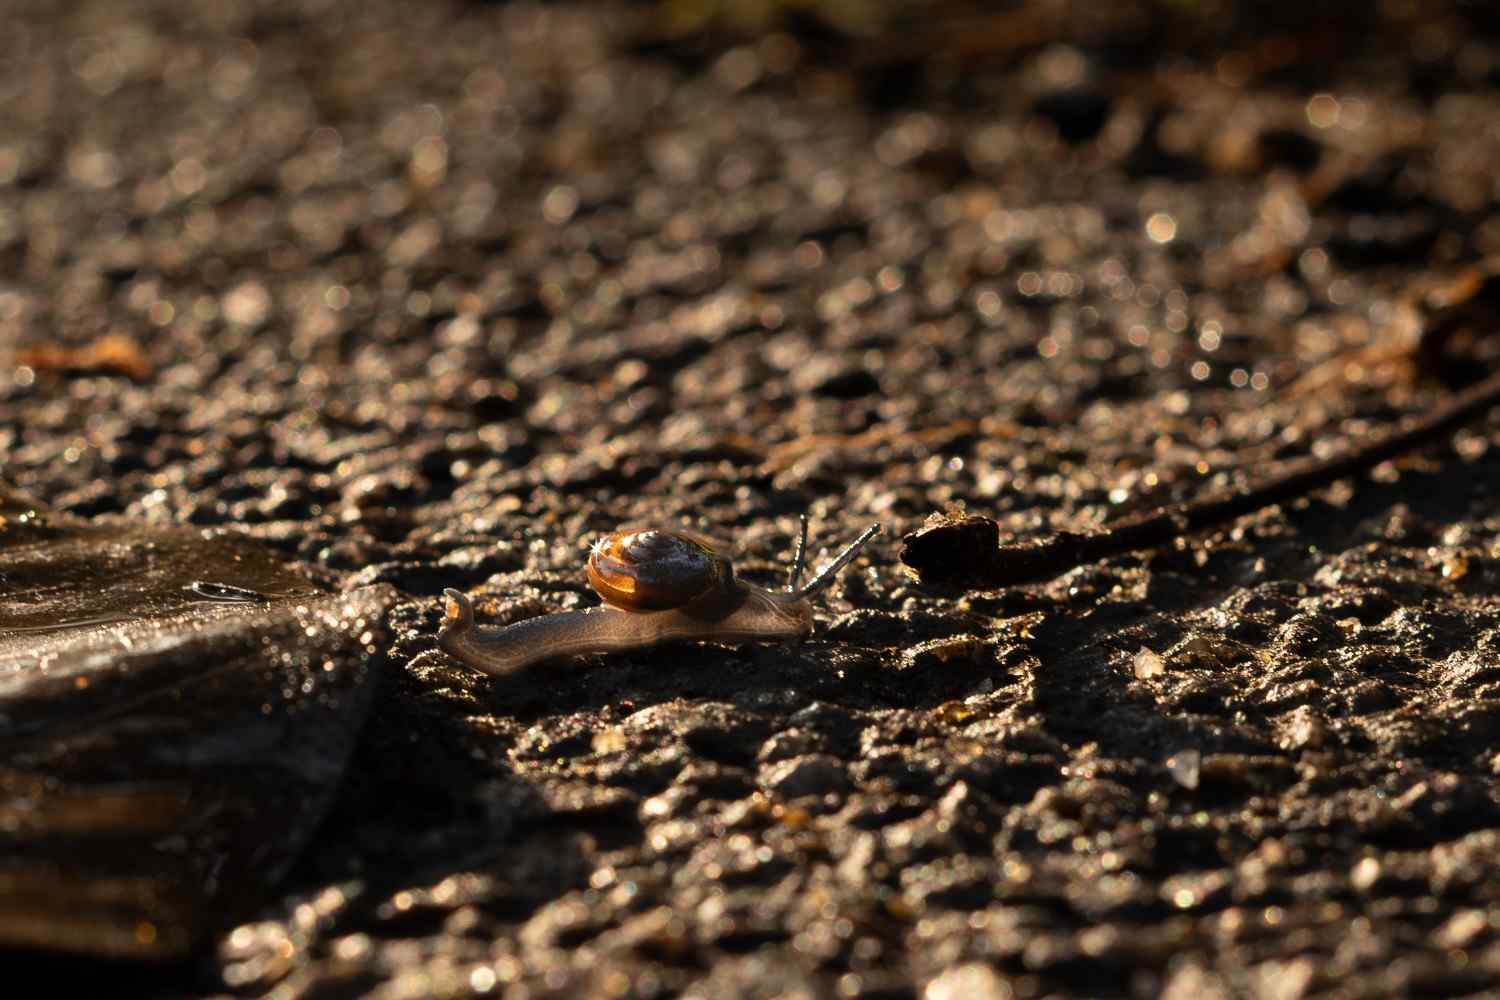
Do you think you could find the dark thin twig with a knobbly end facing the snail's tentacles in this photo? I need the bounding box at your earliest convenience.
[902,365,1500,589]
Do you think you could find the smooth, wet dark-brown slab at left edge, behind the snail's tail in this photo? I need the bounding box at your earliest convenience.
[0,495,395,960]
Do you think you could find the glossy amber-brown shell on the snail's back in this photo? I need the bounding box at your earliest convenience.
[587,529,734,612]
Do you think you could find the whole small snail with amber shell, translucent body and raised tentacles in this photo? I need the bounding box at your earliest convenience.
[438,517,881,675]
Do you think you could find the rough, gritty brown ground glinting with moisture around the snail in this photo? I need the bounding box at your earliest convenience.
[0,0,1500,1000]
